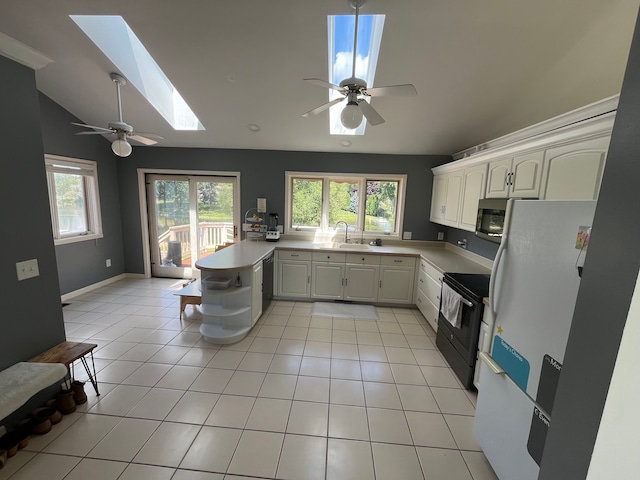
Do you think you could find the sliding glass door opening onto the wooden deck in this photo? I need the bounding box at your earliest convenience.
[147,175,240,278]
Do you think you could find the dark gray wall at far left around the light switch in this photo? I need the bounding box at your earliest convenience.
[0,56,65,369]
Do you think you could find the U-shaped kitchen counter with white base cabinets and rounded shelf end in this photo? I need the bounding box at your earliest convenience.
[196,240,491,344]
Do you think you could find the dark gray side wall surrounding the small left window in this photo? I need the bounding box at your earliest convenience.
[39,94,125,294]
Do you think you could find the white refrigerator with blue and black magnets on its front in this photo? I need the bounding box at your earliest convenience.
[474,200,596,480]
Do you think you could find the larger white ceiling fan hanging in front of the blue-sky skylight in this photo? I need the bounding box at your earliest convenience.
[302,0,418,130]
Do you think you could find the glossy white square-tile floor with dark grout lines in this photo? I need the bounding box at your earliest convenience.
[0,279,496,480]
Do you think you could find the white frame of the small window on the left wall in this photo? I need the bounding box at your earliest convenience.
[44,154,104,245]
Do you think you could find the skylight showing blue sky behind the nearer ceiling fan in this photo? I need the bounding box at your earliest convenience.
[327,15,385,135]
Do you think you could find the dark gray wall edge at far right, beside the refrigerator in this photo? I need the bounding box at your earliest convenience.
[539,8,640,480]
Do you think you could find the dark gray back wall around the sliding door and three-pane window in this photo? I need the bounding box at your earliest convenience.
[118,147,451,273]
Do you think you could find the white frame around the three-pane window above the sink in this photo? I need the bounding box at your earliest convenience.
[284,171,407,240]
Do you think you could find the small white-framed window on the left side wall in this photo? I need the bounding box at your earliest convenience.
[45,155,102,245]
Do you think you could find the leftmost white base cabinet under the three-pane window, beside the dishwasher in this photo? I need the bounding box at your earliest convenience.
[276,250,311,298]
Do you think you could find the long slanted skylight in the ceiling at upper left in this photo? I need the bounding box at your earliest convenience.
[70,15,205,130]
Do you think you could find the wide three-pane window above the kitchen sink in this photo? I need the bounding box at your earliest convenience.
[285,172,406,238]
